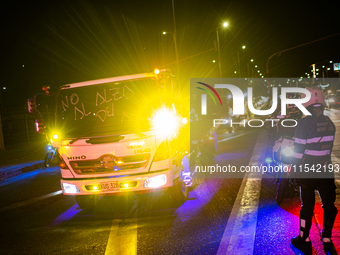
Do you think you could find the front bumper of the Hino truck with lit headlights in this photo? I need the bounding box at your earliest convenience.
[60,169,173,196]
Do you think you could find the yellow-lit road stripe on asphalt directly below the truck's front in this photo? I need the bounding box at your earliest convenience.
[105,198,138,255]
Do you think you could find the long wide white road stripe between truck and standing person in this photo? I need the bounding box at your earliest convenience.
[217,132,267,255]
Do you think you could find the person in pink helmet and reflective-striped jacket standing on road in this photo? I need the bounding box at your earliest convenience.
[291,88,338,254]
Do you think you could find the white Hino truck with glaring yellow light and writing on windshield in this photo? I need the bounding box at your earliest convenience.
[29,69,194,209]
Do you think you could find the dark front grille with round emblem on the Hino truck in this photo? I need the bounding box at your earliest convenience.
[70,153,150,174]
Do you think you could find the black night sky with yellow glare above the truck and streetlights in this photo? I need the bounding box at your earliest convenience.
[1,0,340,111]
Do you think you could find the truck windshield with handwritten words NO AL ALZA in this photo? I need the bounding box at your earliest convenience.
[57,78,161,138]
